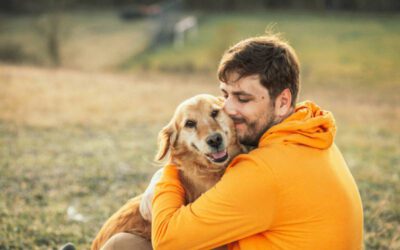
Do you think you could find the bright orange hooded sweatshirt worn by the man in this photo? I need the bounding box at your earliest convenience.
[152,102,363,250]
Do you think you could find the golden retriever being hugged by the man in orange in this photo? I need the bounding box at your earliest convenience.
[92,94,243,250]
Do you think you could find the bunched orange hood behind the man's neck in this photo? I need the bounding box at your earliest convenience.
[259,101,336,149]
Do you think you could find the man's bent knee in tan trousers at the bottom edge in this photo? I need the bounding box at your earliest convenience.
[101,233,153,250]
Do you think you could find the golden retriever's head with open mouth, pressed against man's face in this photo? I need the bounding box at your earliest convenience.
[156,94,239,169]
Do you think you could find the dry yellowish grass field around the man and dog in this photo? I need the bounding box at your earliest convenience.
[0,65,400,249]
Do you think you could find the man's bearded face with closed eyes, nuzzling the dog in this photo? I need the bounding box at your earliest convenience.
[220,73,277,146]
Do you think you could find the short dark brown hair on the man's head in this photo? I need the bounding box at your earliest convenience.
[218,35,300,106]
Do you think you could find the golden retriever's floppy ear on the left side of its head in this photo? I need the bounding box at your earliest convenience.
[155,121,177,161]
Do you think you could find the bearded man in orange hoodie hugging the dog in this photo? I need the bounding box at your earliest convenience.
[103,36,363,250]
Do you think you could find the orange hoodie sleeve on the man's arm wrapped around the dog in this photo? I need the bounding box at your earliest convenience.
[152,155,276,249]
